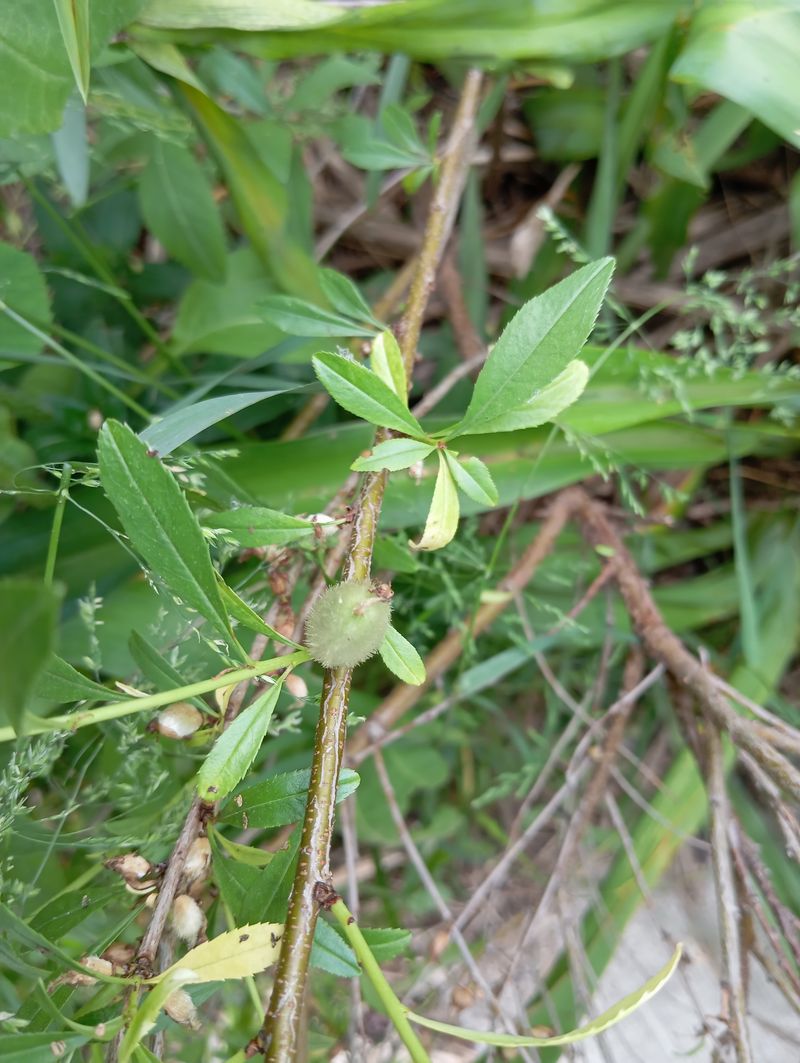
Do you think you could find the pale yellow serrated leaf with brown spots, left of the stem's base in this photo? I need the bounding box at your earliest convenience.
[152,923,284,982]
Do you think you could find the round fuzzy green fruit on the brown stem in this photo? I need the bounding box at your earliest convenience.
[306,579,392,668]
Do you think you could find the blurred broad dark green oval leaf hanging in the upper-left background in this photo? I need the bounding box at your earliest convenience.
[139,136,225,282]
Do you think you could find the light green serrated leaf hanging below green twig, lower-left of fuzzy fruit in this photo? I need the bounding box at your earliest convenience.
[197,676,284,802]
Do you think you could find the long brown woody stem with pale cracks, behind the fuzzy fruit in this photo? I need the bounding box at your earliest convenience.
[259,70,481,1063]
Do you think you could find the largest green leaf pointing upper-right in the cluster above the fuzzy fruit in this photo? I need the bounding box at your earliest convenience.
[449,258,614,436]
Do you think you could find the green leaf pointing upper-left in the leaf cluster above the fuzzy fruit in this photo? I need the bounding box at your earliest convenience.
[312,352,425,437]
